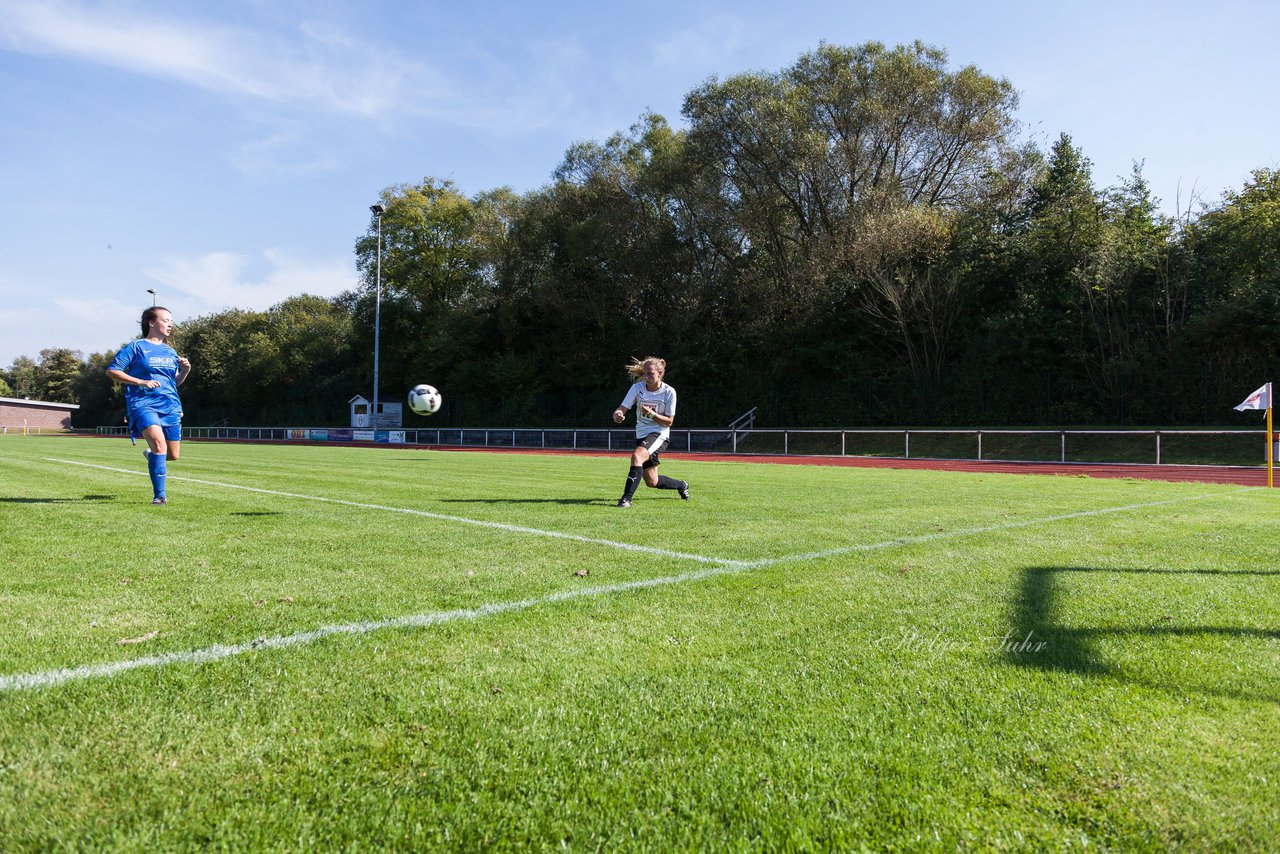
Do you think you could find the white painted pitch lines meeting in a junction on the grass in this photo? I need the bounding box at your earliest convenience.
[0,460,1229,694]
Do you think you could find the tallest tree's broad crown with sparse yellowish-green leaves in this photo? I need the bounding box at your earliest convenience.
[684,42,1018,315]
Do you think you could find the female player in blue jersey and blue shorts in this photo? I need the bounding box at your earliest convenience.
[106,306,191,504]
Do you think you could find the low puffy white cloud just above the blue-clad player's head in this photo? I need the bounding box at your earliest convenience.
[145,248,357,318]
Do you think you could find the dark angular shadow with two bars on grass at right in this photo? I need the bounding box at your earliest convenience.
[1001,566,1280,703]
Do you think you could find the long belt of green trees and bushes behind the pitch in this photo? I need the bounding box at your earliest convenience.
[8,42,1280,426]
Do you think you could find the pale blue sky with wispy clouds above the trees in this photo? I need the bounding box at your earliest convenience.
[0,0,1280,367]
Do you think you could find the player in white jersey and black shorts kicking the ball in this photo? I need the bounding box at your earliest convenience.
[613,356,689,507]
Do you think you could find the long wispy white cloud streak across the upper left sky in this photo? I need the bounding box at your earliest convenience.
[0,0,590,133]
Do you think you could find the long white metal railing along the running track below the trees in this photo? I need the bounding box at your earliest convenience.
[99,426,1266,466]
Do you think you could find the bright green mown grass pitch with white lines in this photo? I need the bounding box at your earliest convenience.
[0,437,1280,851]
